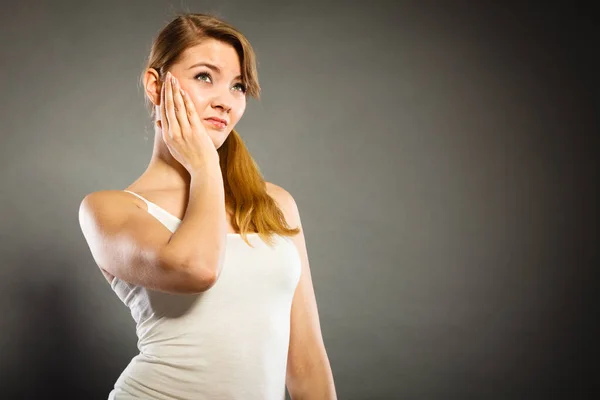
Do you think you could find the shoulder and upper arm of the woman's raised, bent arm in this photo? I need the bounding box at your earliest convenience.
[79,191,211,293]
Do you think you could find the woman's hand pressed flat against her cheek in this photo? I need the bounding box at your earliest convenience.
[159,72,219,174]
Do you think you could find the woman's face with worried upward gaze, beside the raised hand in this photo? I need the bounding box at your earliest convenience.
[156,39,246,149]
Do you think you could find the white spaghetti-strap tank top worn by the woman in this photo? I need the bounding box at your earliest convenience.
[108,190,301,400]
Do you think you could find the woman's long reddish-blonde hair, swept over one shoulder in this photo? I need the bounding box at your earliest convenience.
[142,13,300,245]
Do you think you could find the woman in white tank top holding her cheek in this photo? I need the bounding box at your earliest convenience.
[79,14,336,400]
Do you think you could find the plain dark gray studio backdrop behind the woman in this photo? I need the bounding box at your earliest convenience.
[0,0,598,400]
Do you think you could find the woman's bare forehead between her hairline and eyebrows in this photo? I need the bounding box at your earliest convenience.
[178,39,241,76]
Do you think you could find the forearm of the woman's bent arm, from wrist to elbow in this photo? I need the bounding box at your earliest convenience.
[167,155,227,276]
